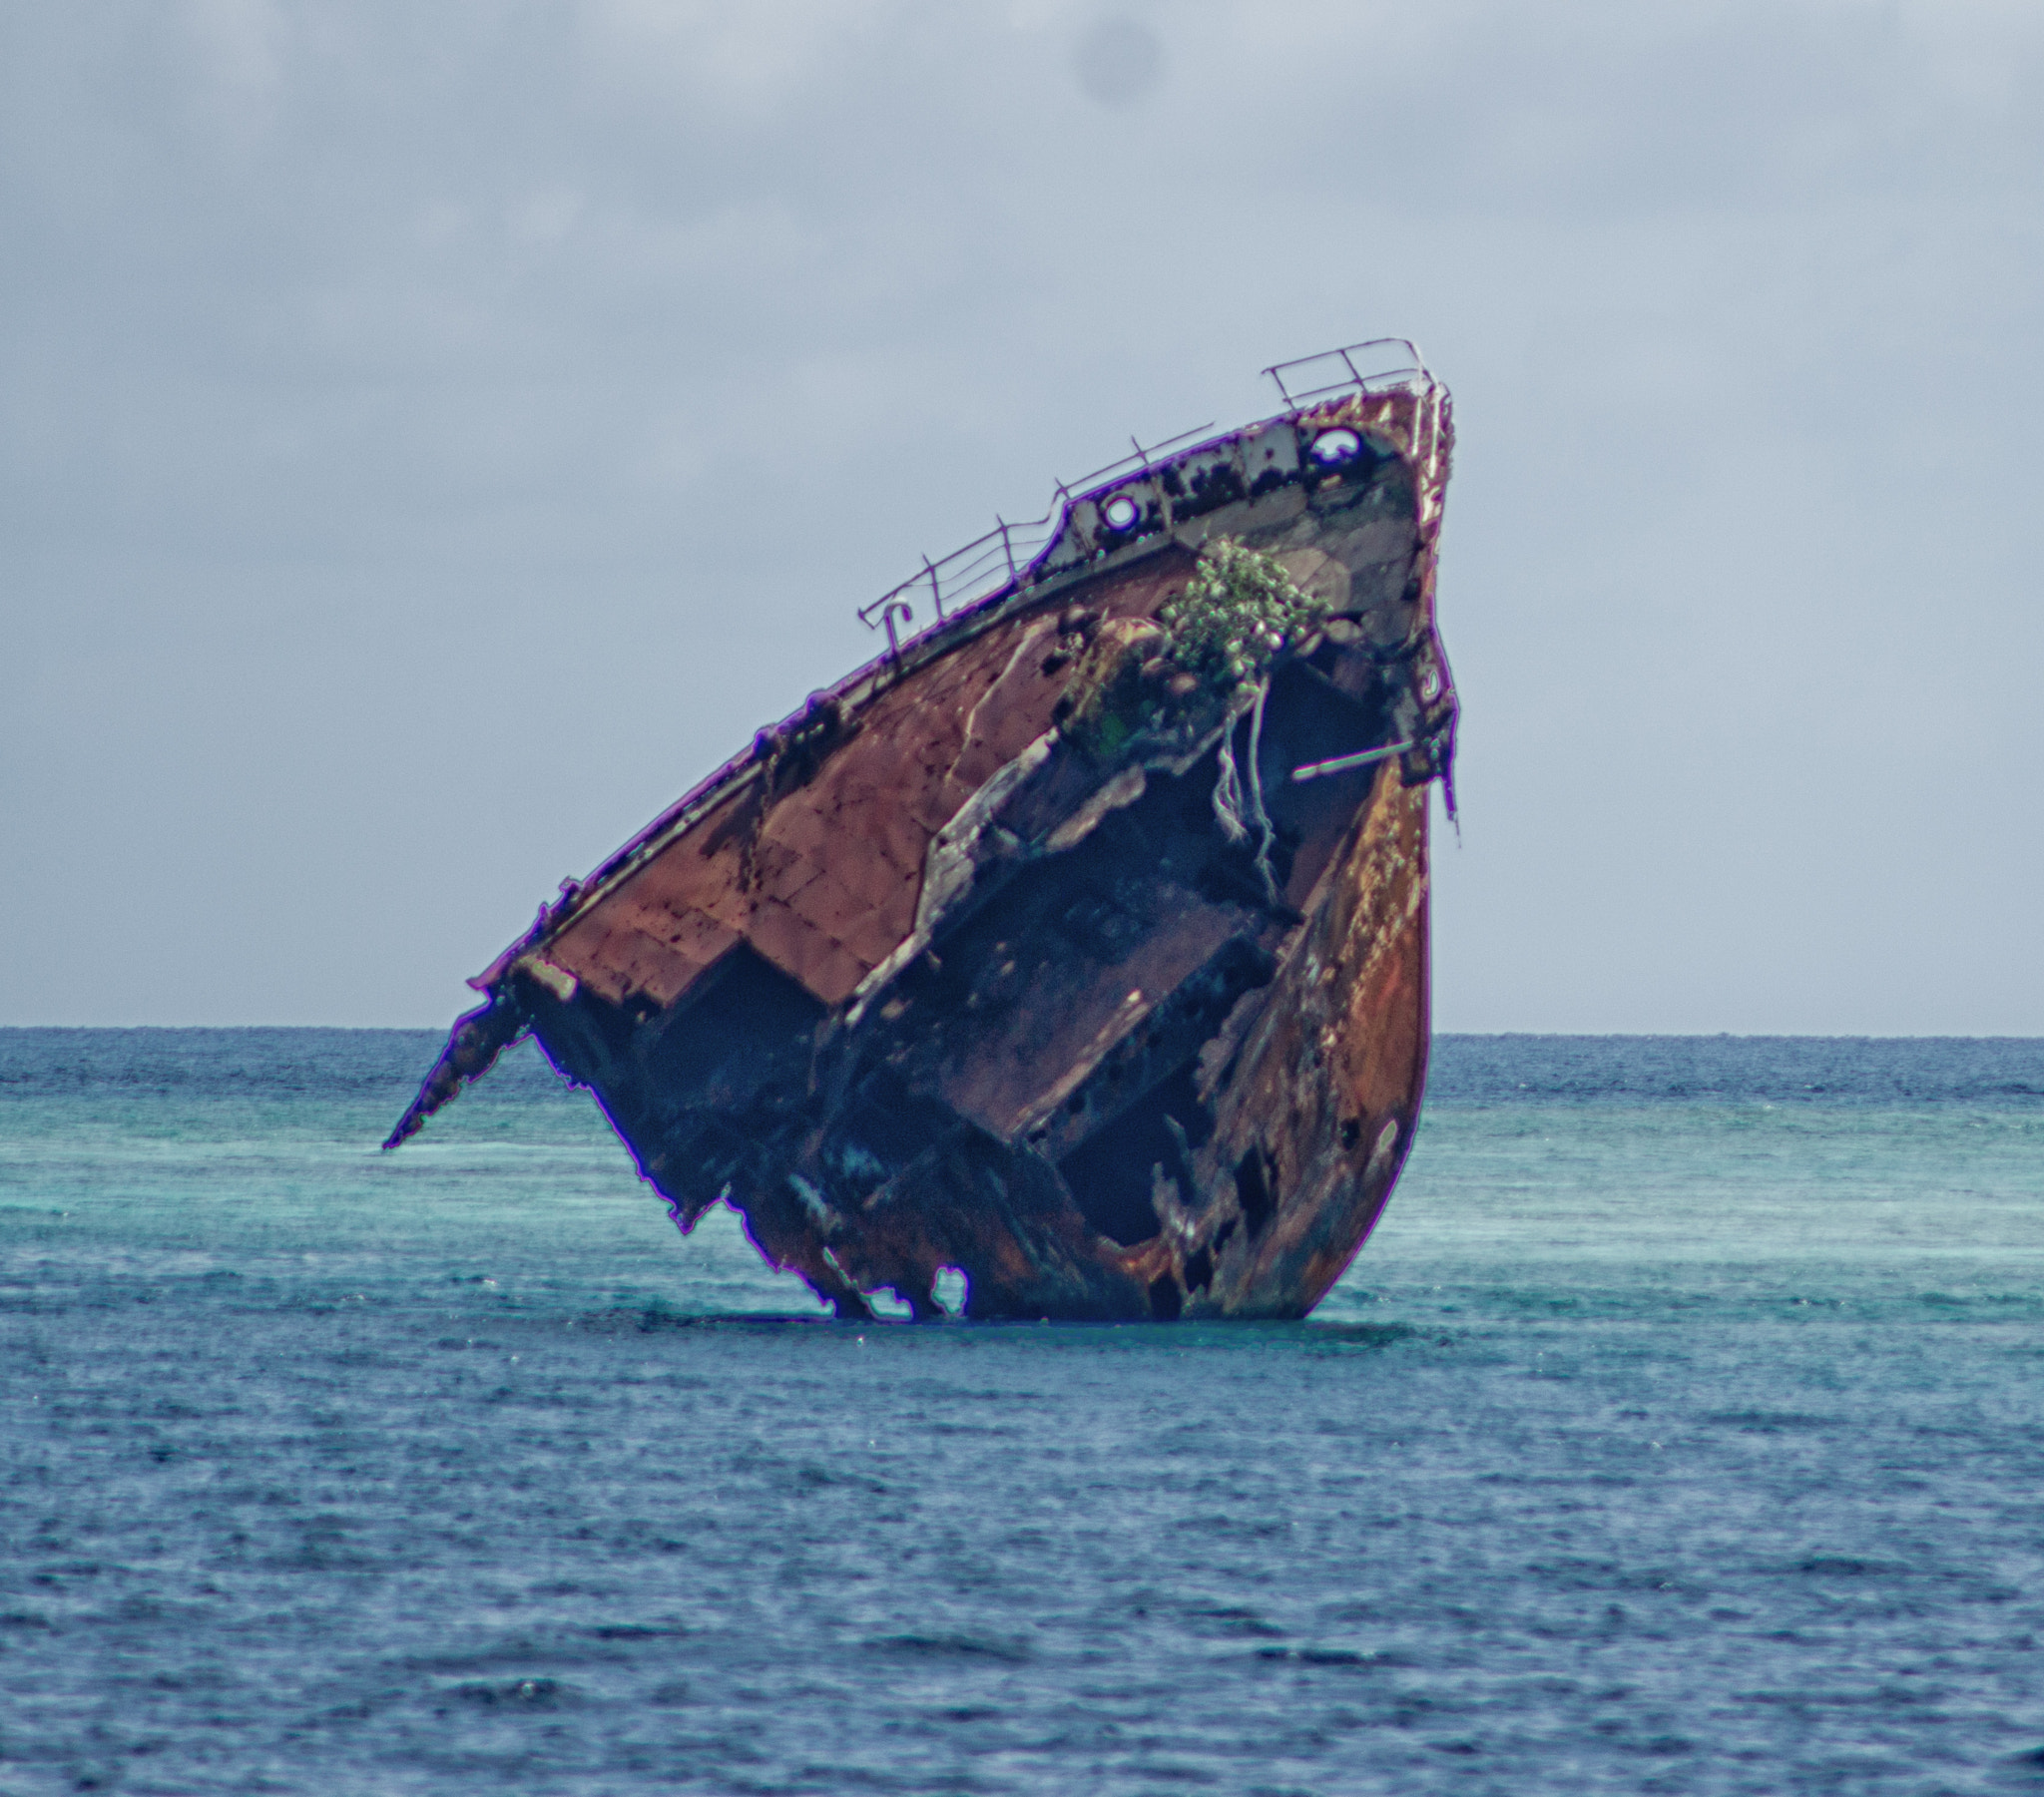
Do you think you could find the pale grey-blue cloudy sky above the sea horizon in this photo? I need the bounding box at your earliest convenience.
[0,0,2044,1035]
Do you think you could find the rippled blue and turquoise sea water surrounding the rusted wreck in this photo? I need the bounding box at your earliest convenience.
[0,1031,2044,1797]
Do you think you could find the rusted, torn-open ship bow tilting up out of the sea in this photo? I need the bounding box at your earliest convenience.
[386,339,1457,1321]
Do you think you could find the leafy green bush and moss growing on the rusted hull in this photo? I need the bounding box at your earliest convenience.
[1063,538,1326,760]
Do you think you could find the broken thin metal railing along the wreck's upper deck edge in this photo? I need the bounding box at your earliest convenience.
[858,337,1433,657]
